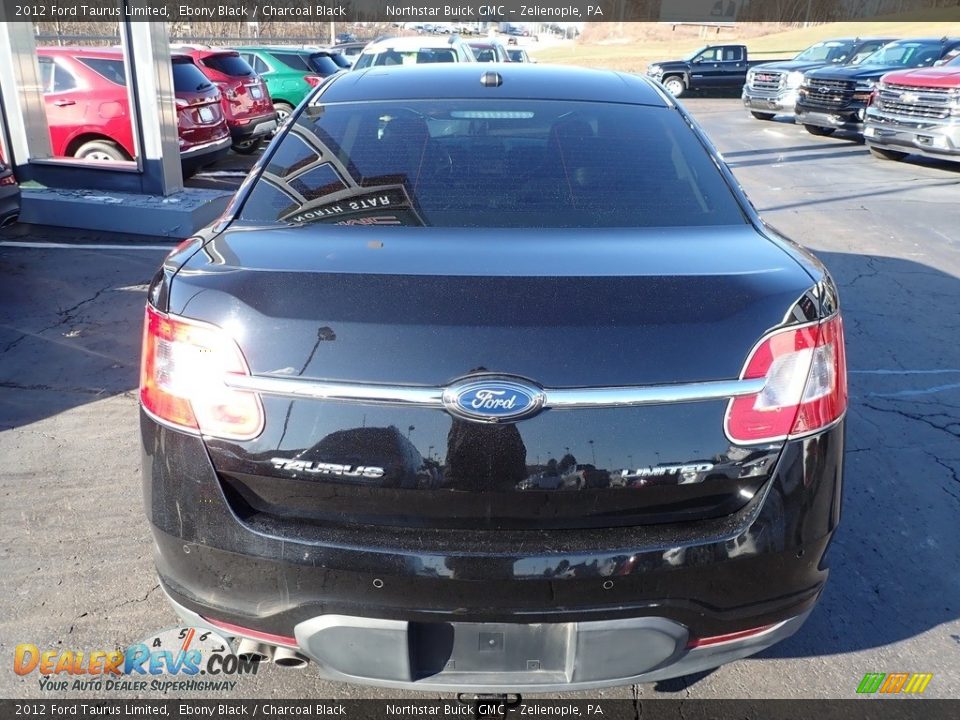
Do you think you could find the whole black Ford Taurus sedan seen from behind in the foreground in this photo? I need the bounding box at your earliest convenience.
[141,64,847,692]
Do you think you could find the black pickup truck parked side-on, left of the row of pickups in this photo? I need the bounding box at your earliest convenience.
[647,45,770,97]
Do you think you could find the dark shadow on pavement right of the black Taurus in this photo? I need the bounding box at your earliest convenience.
[758,253,960,658]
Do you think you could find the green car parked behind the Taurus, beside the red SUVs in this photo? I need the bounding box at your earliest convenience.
[235,46,350,122]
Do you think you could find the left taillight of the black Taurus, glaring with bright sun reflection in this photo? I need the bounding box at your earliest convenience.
[140,305,263,440]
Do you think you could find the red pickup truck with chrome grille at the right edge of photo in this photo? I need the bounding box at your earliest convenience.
[863,55,960,162]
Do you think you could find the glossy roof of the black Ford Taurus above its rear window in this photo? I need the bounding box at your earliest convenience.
[318,63,673,107]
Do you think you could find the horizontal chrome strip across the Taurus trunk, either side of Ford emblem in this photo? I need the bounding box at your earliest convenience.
[225,375,765,410]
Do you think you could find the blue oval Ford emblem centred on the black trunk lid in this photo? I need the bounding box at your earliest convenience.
[443,377,545,423]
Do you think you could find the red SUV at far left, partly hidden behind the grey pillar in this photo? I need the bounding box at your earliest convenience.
[37,47,230,174]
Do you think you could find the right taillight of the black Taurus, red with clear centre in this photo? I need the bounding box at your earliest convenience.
[725,314,847,444]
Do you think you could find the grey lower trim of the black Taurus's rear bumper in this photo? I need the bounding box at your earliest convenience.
[167,594,810,693]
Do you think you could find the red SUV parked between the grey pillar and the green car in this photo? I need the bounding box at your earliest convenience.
[177,46,277,155]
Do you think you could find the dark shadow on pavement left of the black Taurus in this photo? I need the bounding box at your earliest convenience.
[0,224,174,430]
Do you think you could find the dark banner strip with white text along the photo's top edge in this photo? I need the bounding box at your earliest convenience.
[0,0,960,25]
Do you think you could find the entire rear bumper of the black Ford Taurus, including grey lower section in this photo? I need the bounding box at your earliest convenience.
[141,414,843,691]
